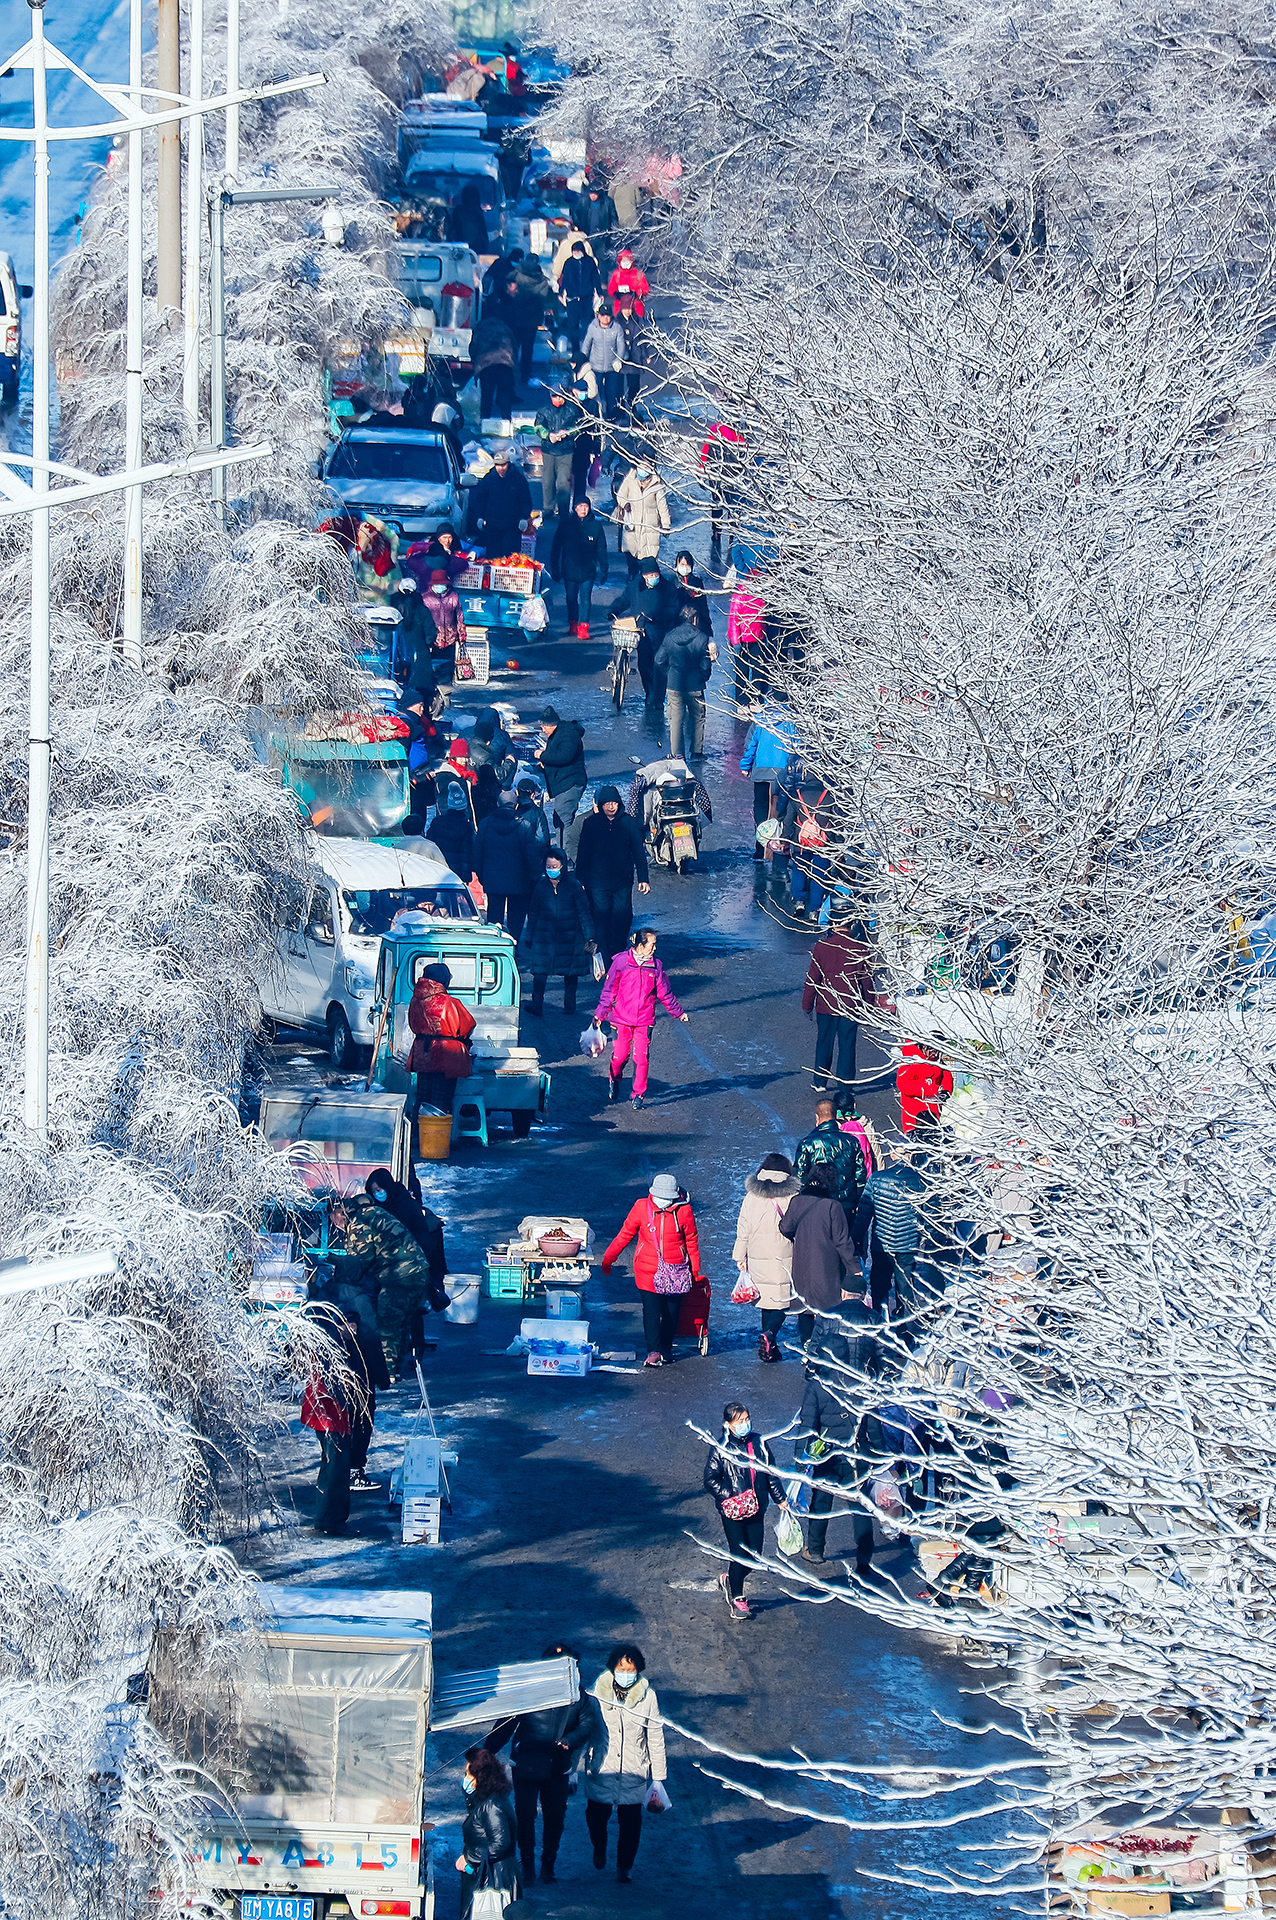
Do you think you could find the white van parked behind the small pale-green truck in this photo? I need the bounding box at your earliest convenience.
[261,835,478,1068]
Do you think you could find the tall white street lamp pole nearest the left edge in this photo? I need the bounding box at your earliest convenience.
[23,0,52,1140]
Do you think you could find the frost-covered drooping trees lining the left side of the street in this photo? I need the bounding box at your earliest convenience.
[0,4,445,1920]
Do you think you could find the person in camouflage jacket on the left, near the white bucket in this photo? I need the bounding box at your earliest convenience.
[342,1167,447,1380]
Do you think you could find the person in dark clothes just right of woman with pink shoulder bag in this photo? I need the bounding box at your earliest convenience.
[798,1300,881,1574]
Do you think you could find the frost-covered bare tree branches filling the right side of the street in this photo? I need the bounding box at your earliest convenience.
[541,0,1276,1899]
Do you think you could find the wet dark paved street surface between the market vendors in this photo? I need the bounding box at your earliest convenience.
[253,560,1013,1920]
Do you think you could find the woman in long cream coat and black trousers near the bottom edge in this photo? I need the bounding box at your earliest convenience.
[585,1642,666,1882]
